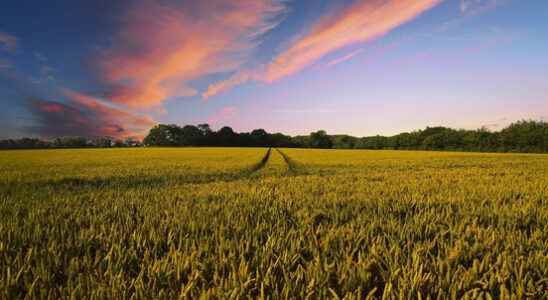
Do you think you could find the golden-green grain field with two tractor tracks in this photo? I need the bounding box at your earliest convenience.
[0,148,548,299]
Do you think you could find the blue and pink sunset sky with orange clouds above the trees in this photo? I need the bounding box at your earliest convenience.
[0,0,548,138]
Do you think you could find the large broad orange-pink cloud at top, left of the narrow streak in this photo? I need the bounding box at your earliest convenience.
[98,0,283,107]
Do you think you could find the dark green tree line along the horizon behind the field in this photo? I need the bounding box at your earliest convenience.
[0,120,548,153]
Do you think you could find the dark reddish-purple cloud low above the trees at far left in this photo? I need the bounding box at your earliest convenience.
[29,90,155,139]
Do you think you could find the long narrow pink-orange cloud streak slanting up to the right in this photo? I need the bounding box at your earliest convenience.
[202,0,442,98]
